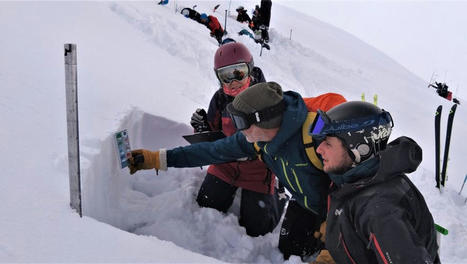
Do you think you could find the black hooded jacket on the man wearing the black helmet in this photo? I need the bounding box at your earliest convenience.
[326,137,439,264]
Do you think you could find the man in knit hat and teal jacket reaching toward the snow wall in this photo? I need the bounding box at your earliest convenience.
[129,82,330,260]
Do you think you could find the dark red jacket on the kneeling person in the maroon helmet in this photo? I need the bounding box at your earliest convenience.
[208,67,276,193]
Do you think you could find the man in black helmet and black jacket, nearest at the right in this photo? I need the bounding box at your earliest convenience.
[311,101,440,263]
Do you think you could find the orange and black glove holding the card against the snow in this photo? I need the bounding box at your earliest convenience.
[128,149,167,174]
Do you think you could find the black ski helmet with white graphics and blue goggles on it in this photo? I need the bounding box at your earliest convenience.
[311,101,394,163]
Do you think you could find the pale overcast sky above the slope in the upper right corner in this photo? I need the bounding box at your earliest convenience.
[273,0,467,100]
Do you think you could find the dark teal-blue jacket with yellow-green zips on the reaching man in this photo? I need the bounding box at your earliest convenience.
[167,91,330,215]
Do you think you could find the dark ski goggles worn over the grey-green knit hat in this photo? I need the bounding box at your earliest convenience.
[227,100,286,130]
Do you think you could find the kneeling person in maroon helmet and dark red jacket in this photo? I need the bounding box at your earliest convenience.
[191,42,287,236]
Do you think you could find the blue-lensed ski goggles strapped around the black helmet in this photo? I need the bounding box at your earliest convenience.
[309,110,394,140]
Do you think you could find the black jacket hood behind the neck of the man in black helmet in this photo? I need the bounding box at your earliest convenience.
[329,137,422,197]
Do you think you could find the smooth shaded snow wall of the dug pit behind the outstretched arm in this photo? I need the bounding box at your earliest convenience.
[82,109,194,232]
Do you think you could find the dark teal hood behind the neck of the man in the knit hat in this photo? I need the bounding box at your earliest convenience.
[258,91,308,155]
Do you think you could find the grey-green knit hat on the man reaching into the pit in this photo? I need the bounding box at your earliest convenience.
[232,82,283,128]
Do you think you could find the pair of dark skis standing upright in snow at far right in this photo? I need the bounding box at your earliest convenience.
[435,104,457,189]
